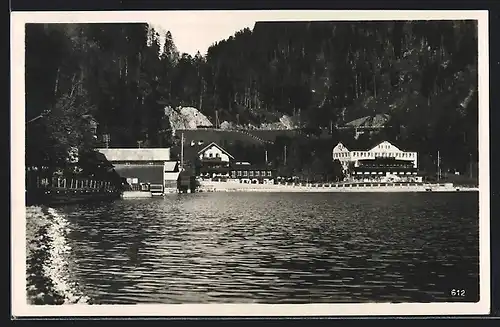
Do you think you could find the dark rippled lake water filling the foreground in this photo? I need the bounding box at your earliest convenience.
[40,192,479,304]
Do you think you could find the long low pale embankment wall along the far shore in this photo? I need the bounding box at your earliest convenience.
[197,181,479,193]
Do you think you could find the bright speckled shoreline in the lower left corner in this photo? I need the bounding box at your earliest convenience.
[26,206,90,305]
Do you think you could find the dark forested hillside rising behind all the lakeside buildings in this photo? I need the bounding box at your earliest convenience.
[26,21,478,178]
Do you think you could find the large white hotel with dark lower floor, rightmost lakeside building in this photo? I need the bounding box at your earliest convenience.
[332,141,422,182]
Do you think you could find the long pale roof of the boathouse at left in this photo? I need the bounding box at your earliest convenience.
[98,148,170,162]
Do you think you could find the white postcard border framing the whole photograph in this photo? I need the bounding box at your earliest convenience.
[11,10,491,317]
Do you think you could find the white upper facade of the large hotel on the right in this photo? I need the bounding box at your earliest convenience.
[332,141,418,169]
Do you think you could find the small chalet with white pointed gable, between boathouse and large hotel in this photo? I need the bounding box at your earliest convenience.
[197,142,234,178]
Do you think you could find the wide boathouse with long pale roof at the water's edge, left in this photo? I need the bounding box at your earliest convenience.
[99,148,179,195]
